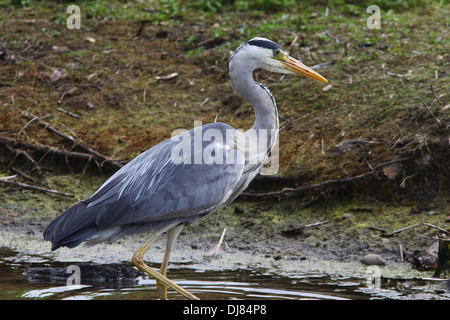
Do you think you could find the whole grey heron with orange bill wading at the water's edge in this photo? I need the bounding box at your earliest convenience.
[43,37,327,299]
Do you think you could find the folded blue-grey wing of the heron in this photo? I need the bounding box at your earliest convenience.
[44,123,244,250]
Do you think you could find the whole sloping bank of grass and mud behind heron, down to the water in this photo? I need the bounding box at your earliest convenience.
[0,1,450,278]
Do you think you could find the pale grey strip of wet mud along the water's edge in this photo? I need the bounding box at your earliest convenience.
[0,216,427,277]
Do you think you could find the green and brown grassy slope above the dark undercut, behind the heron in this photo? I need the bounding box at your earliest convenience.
[0,0,450,222]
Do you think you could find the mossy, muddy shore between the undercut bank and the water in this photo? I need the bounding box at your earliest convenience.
[0,190,448,273]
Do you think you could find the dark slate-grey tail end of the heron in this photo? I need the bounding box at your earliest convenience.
[43,201,98,251]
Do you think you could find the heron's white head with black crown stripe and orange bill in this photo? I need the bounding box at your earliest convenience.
[230,37,328,82]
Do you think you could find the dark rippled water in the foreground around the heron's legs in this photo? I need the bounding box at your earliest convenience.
[0,248,450,300]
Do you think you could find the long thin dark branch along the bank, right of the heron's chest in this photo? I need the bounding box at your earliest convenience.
[241,157,412,198]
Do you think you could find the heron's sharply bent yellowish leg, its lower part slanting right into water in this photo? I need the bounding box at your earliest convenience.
[132,230,198,300]
